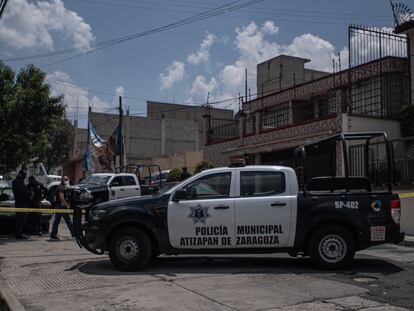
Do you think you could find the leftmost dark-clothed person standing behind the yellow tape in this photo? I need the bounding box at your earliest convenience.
[12,169,29,240]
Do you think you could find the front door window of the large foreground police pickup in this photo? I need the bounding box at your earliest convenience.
[185,172,231,200]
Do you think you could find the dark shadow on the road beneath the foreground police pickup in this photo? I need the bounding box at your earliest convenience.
[76,256,404,276]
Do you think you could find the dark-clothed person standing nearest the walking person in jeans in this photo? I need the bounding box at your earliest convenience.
[27,175,47,235]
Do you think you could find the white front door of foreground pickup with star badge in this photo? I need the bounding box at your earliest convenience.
[168,170,235,249]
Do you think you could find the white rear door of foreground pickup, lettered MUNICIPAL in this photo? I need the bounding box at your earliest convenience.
[235,170,292,248]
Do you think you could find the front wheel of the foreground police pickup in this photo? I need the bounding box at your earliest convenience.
[109,227,152,271]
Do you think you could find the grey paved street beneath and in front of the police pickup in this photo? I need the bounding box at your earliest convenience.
[0,226,414,310]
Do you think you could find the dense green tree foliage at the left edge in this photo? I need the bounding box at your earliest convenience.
[0,61,68,171]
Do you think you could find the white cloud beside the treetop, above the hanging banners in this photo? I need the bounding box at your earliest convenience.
[46,71,112,127]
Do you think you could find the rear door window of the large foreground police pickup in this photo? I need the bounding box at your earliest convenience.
[240,171,285,197]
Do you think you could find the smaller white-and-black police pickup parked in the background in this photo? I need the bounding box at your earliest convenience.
[66,173,141,207]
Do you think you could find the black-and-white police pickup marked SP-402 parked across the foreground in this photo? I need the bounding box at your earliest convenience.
[74,133,404,271]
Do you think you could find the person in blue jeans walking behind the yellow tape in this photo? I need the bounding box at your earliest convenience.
[50,176,75,240]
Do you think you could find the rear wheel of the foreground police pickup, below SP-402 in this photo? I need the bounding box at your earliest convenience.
[308,226,355,269]
